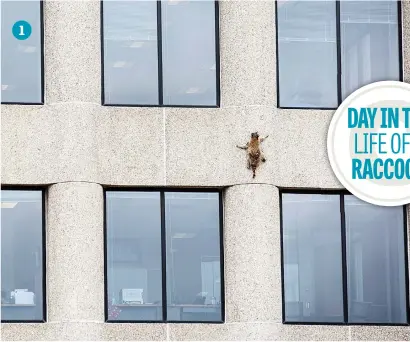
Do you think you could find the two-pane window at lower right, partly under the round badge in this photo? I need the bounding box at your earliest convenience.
[282,193,408,324]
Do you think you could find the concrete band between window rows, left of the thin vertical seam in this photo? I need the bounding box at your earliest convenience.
[1,103,164,185]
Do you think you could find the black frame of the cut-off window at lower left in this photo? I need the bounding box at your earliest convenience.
[1,185,47,323]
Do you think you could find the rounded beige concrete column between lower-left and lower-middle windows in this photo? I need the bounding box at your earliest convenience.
[46,182,104,323]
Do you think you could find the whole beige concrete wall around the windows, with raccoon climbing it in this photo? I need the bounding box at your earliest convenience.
[1,0,410,340]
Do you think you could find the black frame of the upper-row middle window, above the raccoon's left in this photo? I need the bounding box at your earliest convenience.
[100,0,221,108]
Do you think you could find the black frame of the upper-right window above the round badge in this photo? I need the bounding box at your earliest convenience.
[275,0,404,110]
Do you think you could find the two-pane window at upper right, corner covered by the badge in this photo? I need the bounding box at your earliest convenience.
[276,0,402,109]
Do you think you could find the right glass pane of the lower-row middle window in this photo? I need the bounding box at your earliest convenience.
[165,192,222,321]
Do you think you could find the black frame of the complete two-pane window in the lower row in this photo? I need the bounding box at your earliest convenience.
[103,187,225,324]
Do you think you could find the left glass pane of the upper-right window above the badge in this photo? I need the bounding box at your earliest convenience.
[277,0,338,108]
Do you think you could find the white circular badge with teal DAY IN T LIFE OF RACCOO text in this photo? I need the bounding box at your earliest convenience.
[327,81,410,206]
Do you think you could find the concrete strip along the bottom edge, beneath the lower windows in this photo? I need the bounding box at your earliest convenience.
[10,322,410,341]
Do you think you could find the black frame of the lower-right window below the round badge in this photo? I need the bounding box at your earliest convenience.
[279,188,410,326]
